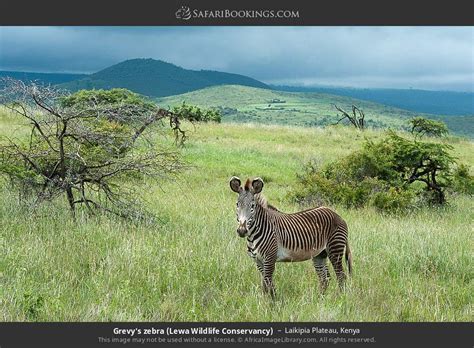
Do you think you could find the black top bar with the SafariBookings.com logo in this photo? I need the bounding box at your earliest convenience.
[0,0,474,25]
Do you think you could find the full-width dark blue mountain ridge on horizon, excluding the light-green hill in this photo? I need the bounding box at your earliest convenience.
[0,58,474,116]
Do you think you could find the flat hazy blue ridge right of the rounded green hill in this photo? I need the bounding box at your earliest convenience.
[271,86,474,116]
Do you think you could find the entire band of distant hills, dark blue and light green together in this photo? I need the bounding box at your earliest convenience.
[0,59,474,137]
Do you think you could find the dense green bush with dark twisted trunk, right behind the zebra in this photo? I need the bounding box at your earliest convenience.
[291,132,464,211]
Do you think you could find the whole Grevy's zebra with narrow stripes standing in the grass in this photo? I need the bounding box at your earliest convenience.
[230,176,352,298]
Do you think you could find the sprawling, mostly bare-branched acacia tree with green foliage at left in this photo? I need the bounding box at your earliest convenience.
[0,79,189,217]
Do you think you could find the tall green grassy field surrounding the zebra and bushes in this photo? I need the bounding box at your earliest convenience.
[0,114,474,321]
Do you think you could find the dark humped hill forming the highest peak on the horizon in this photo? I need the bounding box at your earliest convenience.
[61,59,268,97]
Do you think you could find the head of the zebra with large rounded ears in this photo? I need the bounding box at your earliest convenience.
[230,176,263,237]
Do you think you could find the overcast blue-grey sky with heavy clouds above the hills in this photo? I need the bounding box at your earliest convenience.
[0,27,474,91]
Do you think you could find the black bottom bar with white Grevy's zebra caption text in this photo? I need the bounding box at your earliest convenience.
[0,323,474,348]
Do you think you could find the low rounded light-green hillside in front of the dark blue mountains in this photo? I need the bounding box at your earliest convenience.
[156,85,474,137]
